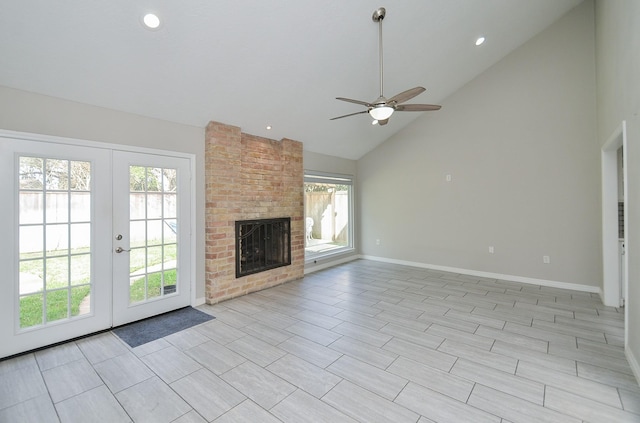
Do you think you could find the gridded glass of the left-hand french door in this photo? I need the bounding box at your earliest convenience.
[18,156,92,328]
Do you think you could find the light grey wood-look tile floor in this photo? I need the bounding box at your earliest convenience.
[0,260,640,423]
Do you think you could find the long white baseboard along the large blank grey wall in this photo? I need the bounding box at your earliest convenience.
[360,255,602,296]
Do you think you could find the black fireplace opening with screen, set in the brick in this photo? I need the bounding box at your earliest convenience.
[236,217,291,278]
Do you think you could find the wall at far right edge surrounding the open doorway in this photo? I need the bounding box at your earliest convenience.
[596,0,640,379]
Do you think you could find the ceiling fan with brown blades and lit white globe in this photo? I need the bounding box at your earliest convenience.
[330,7,442,125]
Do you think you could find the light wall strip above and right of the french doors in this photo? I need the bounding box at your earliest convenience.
[0,86,205,298]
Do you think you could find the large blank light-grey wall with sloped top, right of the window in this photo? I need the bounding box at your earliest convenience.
[358,1,601,290]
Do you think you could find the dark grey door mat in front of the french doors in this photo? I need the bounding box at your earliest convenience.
[113,307,215,348]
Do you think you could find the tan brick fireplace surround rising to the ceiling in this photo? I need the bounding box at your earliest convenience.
[205,122,304,304]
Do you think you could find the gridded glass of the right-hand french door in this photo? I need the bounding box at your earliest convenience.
[129,166,179,304]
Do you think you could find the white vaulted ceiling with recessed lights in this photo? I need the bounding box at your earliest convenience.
[0,0,581,159]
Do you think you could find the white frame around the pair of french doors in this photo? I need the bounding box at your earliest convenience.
[0,129,197,358]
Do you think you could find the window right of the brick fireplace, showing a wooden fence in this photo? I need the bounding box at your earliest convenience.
[304,171,353,260]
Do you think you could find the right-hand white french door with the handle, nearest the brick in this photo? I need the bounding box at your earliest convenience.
[113,151,191,326]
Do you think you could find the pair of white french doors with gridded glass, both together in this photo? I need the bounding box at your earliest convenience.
[0,134,191,357]
